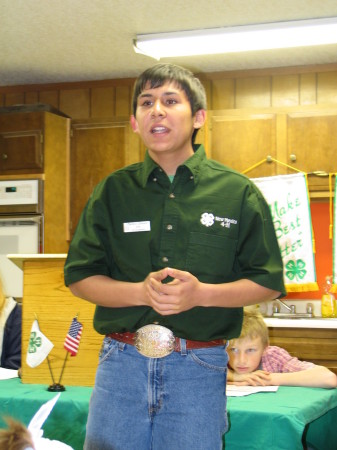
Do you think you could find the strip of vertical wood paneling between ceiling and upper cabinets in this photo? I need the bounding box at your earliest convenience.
[0,64,337,119]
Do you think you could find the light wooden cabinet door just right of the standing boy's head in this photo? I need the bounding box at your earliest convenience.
[208,111,276,177]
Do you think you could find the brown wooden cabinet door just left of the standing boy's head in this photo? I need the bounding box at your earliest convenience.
[70,120,145,236]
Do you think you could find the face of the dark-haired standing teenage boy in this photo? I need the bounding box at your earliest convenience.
[131,82,205,162]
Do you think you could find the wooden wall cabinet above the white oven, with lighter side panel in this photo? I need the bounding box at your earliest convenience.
[0,104,70,253]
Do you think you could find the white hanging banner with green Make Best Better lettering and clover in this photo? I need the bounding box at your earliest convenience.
[252,173,318,292]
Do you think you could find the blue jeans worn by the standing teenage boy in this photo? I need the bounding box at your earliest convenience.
[84,337,228,450]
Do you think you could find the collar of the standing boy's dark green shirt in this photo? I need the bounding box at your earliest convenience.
[141,144,207,187]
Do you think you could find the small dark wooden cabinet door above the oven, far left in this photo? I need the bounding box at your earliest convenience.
[0,130,43,174]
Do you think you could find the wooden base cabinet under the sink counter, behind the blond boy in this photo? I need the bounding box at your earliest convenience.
[268,327,337,374]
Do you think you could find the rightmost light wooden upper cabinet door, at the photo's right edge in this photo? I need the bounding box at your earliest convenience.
[287,109,337,191]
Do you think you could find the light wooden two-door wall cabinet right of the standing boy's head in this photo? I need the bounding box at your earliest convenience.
[208,106,337,196]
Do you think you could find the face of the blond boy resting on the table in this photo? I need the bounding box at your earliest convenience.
[228,336,264,374]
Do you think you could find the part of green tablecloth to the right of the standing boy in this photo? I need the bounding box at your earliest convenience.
[224,386,337,450]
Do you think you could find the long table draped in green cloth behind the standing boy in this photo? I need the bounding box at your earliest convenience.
[0,378,337,450]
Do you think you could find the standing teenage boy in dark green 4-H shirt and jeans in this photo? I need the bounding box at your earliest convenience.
[65,64,285,450]
